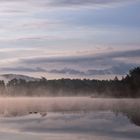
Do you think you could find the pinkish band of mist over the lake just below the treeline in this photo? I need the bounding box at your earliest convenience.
[0,97,140,116]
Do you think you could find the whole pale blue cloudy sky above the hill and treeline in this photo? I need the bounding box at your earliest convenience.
[0,0,140,79]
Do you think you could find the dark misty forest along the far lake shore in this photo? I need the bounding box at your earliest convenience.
[0,67,140,98]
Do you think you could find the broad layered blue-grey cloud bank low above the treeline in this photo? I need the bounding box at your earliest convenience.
[14,49,140,76]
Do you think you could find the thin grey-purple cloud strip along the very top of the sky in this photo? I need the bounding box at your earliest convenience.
[0,0,138,8]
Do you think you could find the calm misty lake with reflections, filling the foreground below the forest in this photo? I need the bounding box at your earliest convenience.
[0,97,140,140]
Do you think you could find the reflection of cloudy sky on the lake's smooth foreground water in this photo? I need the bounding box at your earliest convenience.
[0,111,140,140]
